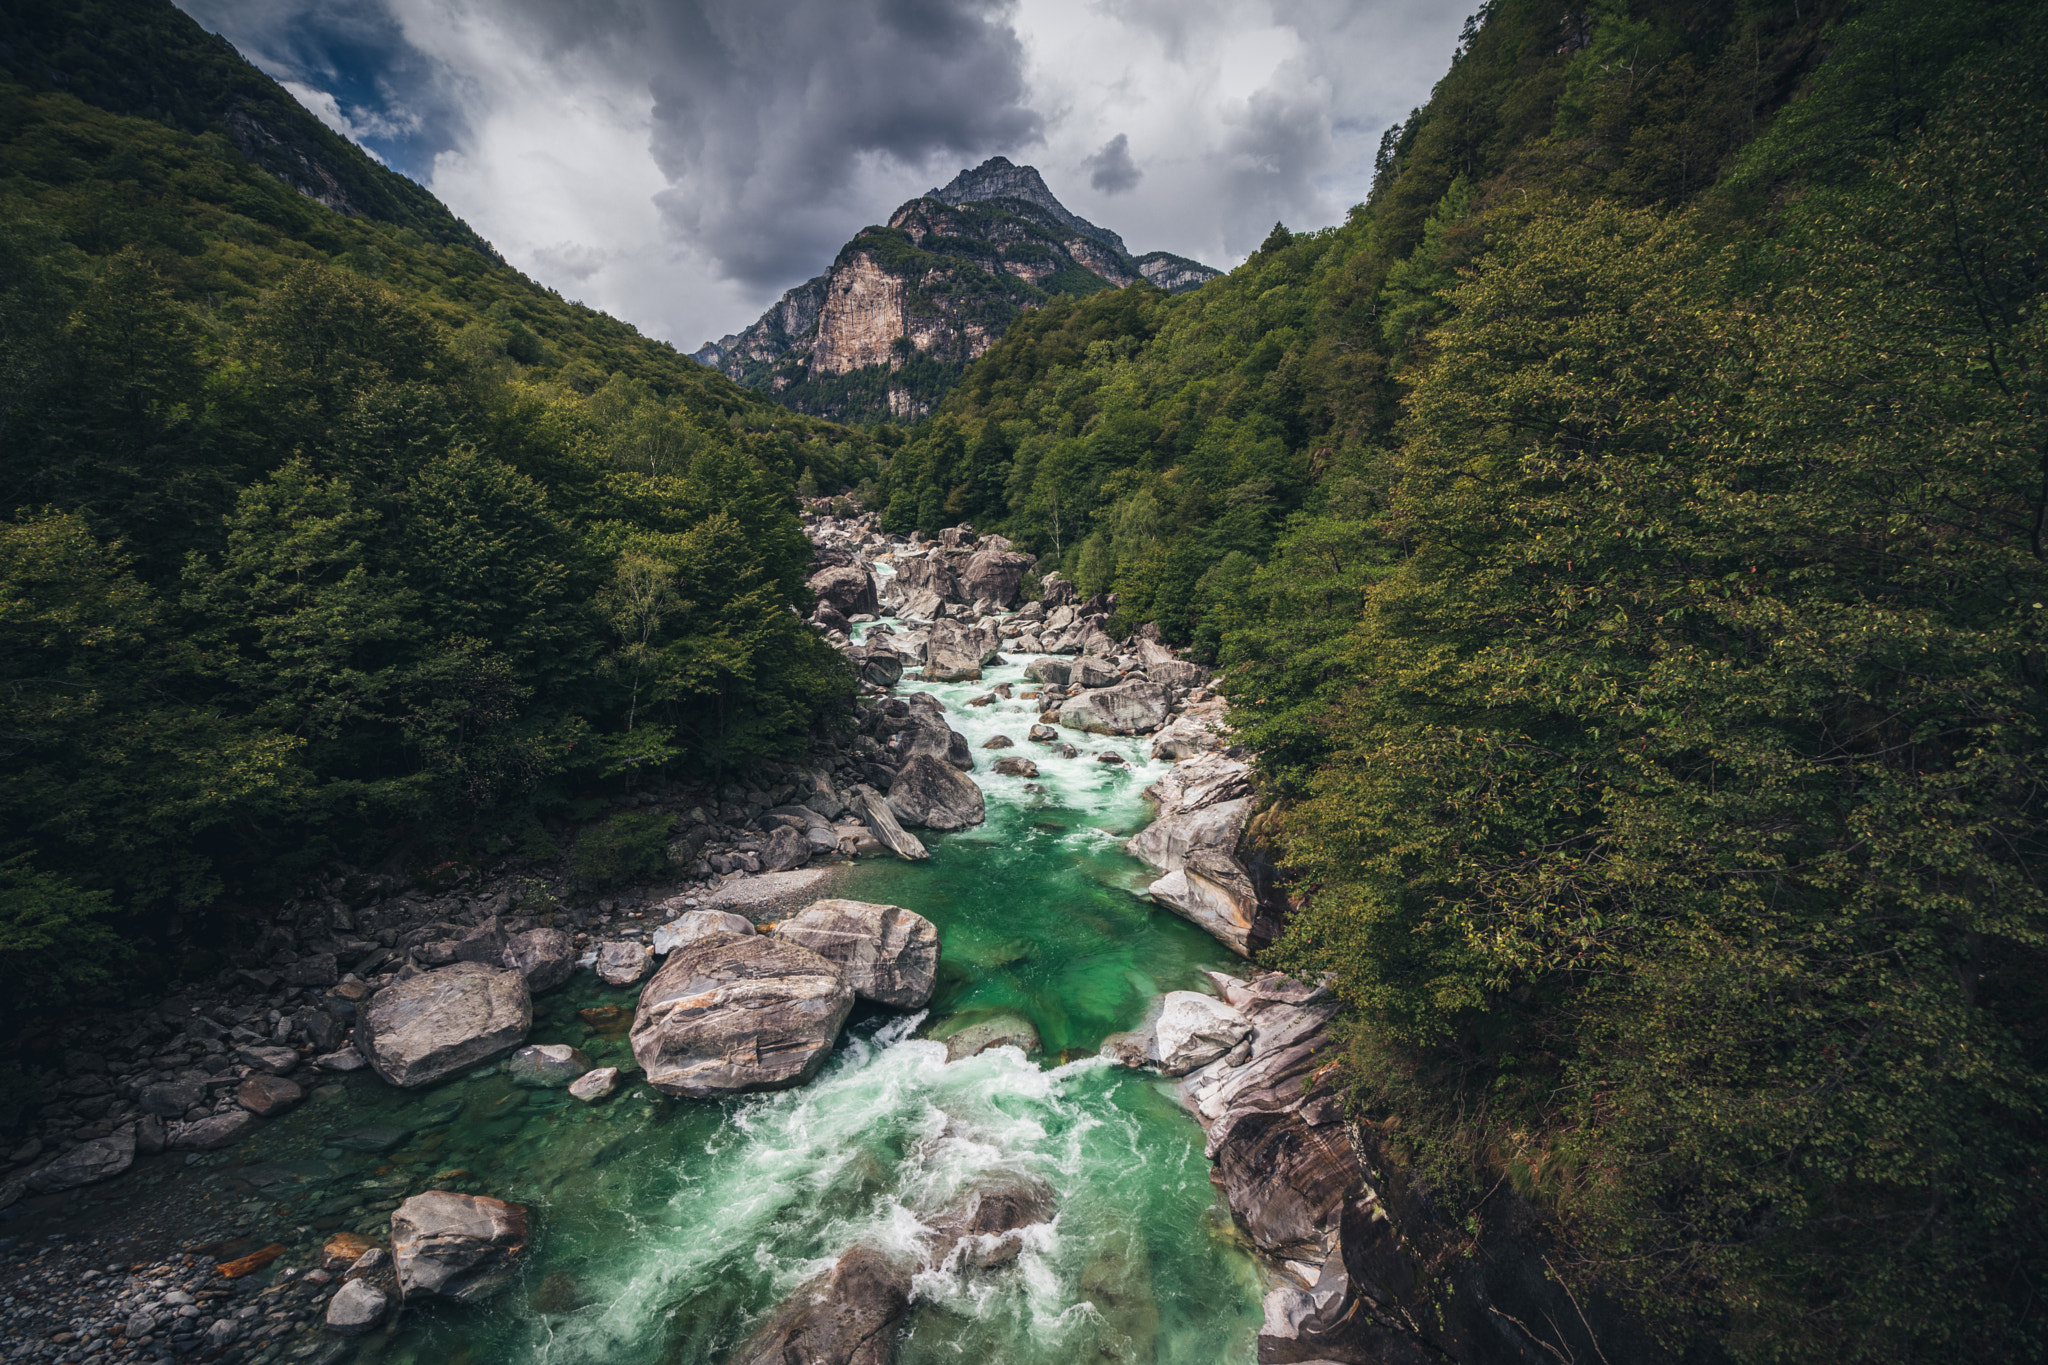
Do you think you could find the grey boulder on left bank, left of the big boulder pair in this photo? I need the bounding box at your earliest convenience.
[356,962,532,1089]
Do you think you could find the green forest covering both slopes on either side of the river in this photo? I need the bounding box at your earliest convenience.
[0,0,2048,1365]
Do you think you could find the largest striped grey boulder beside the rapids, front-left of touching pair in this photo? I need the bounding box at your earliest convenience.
[633,933,854,1099]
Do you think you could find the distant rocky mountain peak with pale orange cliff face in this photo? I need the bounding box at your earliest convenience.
[696,158,1221,420]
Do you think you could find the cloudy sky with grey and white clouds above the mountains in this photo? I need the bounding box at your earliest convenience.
[178,0,1477,350]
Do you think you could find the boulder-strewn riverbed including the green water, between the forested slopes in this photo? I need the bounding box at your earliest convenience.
[0,518,1400,1365]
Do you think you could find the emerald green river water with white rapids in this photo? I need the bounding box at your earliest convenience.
[184,646,1262,1365]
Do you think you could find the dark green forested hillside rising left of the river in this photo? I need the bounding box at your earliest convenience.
[0,2,870,1011]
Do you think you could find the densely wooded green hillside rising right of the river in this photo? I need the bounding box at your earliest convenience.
[862,0,2048,1361]
